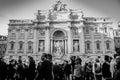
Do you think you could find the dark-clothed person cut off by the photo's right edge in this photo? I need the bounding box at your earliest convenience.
[113,56,120,80]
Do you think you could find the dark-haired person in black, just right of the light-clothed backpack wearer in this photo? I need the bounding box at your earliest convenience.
[102,55,112,80]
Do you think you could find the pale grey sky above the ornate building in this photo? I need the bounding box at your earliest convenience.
[0,0,120,35]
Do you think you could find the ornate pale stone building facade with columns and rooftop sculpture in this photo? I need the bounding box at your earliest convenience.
[6,1,115,59]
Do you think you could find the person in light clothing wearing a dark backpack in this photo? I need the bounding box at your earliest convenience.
[93,58,102,80]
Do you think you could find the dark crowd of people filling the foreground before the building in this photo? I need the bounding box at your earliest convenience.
[0,53,120,80]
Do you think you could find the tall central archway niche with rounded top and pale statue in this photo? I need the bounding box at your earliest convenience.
[51,30,67,58]
